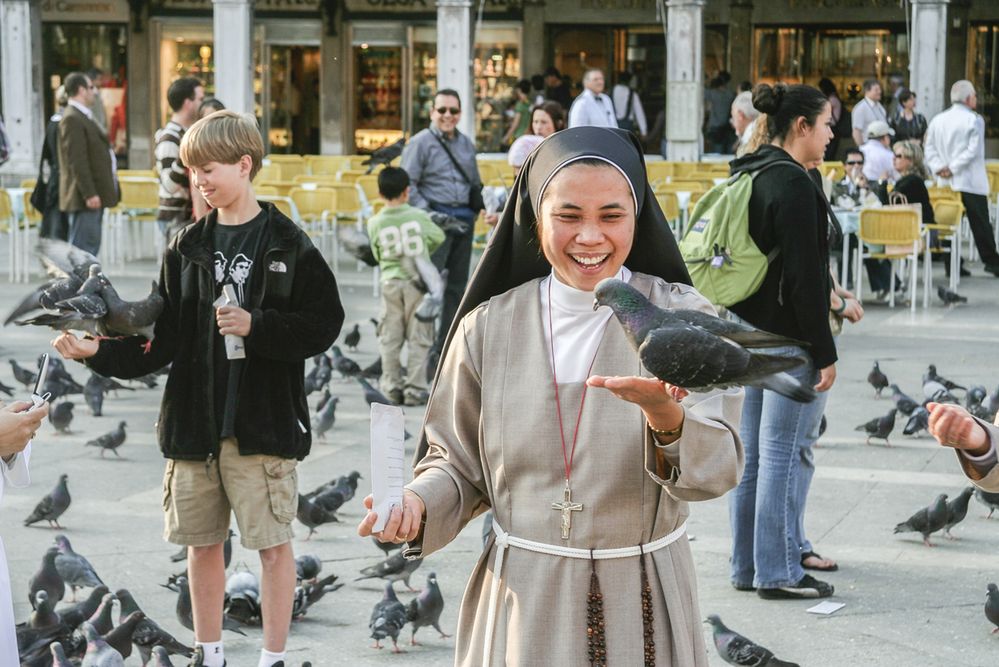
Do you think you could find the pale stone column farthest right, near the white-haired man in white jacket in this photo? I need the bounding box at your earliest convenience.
[909,0,950,118]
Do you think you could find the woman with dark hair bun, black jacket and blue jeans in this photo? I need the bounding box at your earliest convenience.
[730,84,836,599]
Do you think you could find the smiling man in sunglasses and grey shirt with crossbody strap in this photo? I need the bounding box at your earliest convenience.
[402,88,496,354]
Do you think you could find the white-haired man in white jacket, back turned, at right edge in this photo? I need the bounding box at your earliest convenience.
[925,79,999,277]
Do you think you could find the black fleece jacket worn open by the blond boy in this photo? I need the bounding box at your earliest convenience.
[87,202,344,460]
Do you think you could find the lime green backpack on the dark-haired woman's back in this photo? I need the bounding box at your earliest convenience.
[680,160,794,307]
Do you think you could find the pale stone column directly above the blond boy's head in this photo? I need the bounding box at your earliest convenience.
[212,0,253,113]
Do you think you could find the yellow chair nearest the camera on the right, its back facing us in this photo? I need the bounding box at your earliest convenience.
[853,208,925,312]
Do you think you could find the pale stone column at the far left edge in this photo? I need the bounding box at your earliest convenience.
[0,0,48,184]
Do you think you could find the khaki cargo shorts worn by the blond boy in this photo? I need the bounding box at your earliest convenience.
[163,438,298,551]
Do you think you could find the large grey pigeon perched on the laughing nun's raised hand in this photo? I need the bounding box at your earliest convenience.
[593,278,816,403]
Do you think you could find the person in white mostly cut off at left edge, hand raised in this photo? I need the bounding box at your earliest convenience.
[0,401,49,667]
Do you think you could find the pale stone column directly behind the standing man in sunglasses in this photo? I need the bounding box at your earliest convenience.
[437,0,475,142]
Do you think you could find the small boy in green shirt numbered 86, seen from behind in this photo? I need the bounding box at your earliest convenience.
[368,167,444,405]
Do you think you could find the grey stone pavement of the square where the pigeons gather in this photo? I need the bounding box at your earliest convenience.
[0,244,999,667]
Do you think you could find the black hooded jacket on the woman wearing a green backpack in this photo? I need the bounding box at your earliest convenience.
[729,145,836,369]
